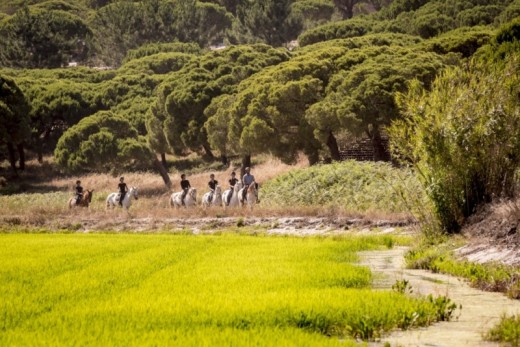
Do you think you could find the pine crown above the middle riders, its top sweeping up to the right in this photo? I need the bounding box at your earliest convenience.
[150,45,289,154]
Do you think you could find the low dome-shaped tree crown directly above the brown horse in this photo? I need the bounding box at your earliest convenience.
[54,111,151,172]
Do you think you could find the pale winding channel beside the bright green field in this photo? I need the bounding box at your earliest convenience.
[361,248,520,347]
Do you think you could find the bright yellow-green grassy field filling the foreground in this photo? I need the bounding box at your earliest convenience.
[0,233,442,346]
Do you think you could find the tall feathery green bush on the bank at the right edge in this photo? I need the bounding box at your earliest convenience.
[390,51,520,232]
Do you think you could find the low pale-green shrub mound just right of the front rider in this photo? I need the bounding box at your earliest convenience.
[260,161,426,212]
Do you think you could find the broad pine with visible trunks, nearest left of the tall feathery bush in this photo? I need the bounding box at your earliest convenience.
[306,46,444,160]
